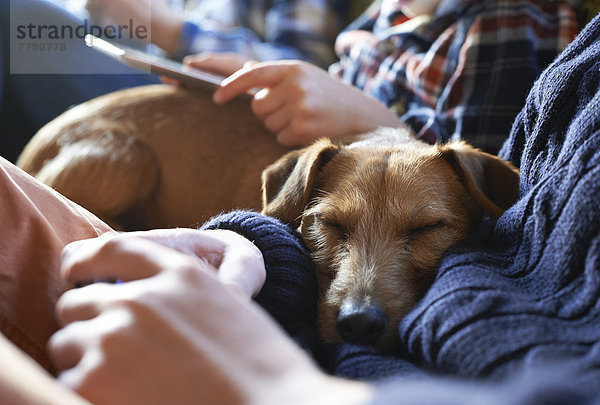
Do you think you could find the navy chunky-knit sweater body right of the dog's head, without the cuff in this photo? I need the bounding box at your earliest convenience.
[400,8,600,382]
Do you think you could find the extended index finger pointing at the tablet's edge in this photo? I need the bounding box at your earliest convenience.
[213,62,288,104]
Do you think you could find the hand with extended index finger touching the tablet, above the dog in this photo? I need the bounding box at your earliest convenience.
[213,61,403,147]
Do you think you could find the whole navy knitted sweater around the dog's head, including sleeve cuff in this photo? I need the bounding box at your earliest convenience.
[207,12,600,404]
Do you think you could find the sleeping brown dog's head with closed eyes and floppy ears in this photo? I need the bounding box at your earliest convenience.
[263,130,518,350]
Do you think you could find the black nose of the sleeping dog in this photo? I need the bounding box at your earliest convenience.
[336,304,387,345]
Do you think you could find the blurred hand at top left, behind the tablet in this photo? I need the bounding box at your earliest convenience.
[86,0,184,54]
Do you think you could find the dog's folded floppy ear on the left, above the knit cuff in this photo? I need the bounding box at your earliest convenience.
[262,139,339,228]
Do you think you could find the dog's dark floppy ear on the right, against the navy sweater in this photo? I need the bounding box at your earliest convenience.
[441,141,519,219]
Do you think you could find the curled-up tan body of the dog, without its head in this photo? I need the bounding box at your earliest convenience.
[18,85,288,230]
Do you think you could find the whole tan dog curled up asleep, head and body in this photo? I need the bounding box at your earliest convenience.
[19,85,518,349]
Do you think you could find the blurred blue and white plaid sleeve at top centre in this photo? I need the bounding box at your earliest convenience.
[176,0,349,67]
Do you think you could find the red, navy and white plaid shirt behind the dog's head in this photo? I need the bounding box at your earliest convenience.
[331,0,577,151]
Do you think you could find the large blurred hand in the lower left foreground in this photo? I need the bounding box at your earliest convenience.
[49,230,370,405]
